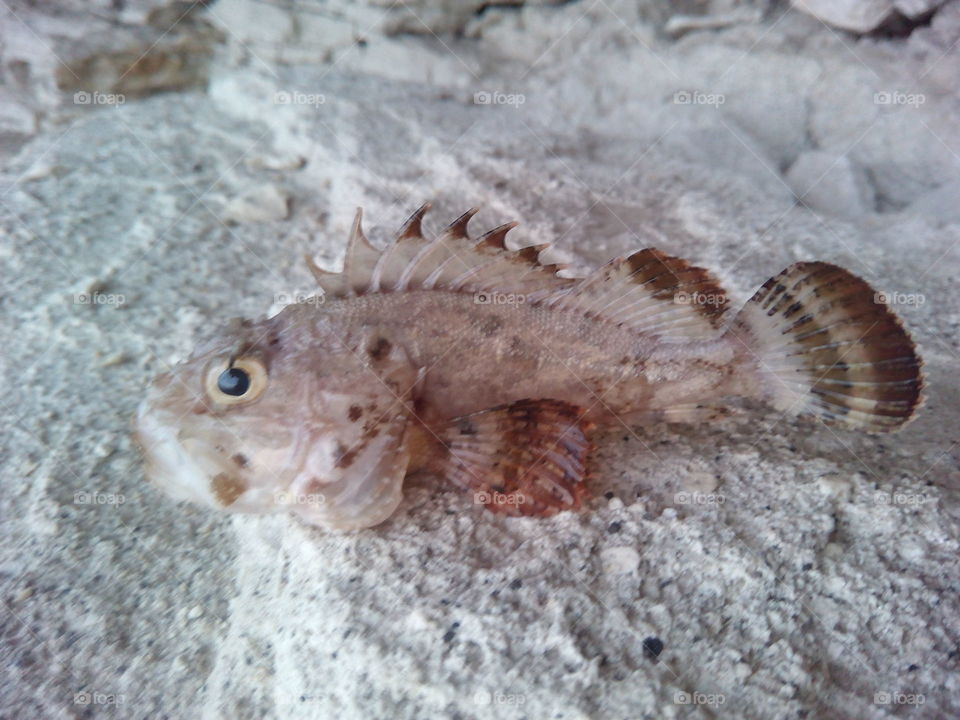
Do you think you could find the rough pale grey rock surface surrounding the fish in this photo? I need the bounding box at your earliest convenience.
[0,0,960,720]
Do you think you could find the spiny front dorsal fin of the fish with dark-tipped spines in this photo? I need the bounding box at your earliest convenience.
[307,204,574,298]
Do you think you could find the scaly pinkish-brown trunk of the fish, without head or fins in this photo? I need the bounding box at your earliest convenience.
[316,290,748,422]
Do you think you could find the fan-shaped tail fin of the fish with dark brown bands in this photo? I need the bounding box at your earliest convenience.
[731,262,923,432]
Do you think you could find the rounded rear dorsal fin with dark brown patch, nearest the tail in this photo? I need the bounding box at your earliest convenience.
[545,248,728,338]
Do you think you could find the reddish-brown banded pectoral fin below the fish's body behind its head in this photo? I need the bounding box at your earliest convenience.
[442,399,591,516]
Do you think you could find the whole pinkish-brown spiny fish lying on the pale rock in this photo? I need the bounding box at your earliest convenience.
[134,203,924,531]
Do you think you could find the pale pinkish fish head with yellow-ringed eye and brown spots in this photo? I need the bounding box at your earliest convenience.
[135,306,416,529]
